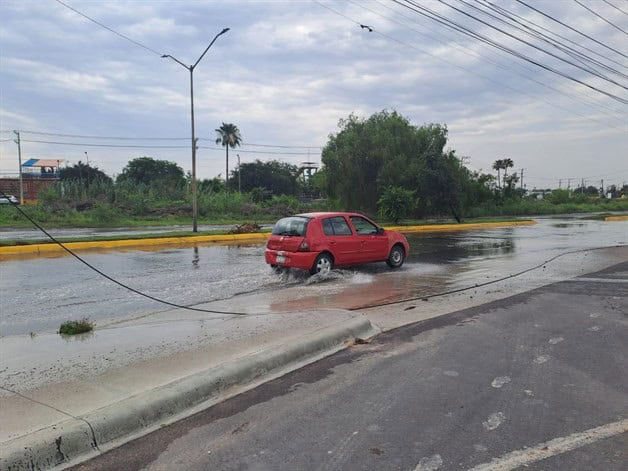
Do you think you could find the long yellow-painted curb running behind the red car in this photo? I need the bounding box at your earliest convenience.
[0,220,536,256]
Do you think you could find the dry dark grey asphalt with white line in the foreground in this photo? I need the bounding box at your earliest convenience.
[71,262,628,471]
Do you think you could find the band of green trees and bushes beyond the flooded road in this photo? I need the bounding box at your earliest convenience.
[0,111,628,231]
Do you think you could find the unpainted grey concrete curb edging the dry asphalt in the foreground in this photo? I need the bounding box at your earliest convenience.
[0,316,379,471]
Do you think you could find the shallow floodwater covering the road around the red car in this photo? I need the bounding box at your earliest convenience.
[0,218,628,336]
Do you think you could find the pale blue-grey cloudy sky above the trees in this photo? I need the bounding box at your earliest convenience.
[0,0,628,189]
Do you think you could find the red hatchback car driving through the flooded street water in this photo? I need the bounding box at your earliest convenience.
[265,212,410,275]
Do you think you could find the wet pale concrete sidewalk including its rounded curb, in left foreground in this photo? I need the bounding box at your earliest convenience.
[0,310,377,470]
